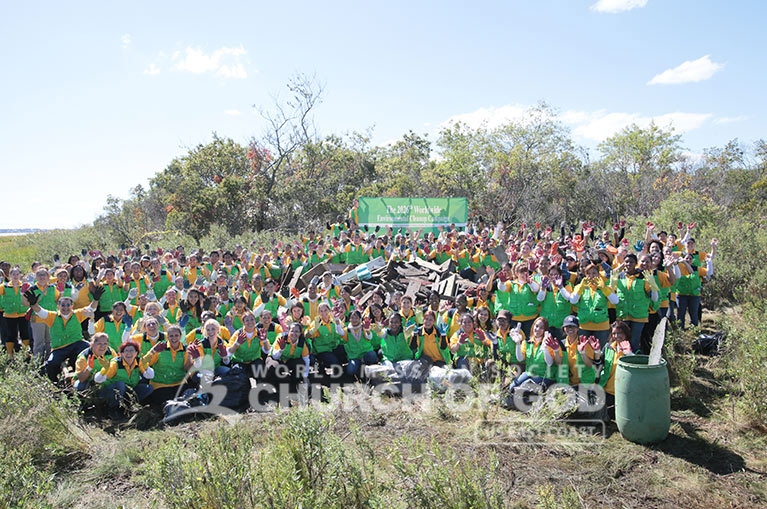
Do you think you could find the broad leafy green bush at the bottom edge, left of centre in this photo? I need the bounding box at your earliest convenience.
[146,408,378,508]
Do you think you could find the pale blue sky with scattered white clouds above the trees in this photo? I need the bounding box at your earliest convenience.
[0,0,767,229]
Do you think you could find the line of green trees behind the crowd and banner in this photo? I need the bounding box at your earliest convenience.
[94,76,767,245]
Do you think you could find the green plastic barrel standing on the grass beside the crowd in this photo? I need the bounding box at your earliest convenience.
[615,355,671,444]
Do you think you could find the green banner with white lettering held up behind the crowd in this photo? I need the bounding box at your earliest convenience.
[357,197,469,231]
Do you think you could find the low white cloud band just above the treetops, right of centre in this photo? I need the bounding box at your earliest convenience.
[439,104,713,142]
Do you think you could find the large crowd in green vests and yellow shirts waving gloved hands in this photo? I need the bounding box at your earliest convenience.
[0,206,717,419]
